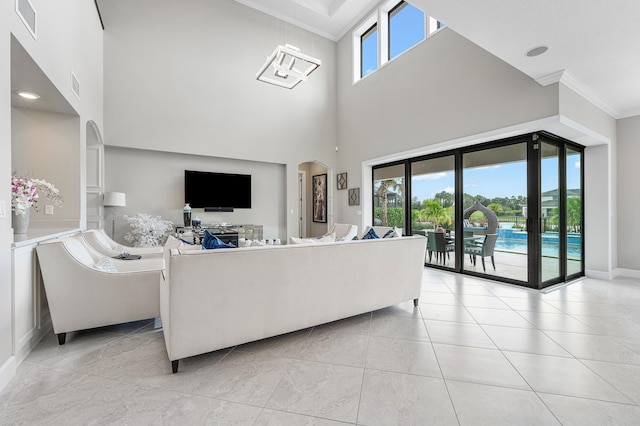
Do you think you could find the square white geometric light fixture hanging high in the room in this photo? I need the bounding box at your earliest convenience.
[256,44,320,89]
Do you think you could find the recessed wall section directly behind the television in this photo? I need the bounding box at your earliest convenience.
[105,147,286,240]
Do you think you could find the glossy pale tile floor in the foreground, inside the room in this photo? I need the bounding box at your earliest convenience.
[0,269,640,426]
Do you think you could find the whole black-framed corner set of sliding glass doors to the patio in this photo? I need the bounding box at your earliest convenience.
[373,132,584,288]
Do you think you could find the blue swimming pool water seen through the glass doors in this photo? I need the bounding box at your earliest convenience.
[496,229,582,259]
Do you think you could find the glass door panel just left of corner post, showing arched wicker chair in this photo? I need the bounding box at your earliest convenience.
[462,141,529,282]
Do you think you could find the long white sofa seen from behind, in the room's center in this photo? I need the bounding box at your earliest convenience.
[160,236,426,373]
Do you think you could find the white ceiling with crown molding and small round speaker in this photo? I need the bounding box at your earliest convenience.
[236,0,640,118]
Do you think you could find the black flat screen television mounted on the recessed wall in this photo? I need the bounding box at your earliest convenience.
[184,170,251,209]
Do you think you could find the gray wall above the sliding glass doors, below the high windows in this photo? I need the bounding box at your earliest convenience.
[335,28,559,230]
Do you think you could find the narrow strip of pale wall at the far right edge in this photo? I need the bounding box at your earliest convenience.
[616,116,640,277]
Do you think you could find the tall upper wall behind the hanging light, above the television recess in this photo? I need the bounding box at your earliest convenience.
[101,0,337,235]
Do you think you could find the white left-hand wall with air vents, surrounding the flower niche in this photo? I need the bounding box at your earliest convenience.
[0,0,103,389]
